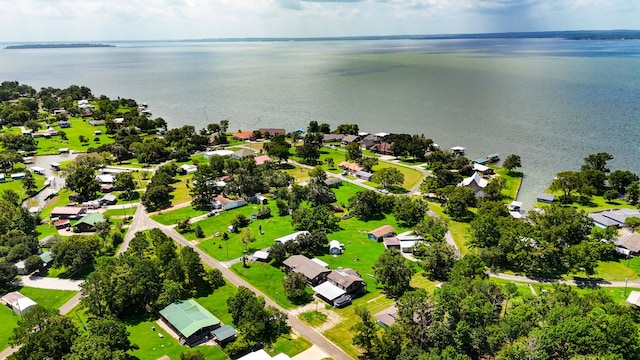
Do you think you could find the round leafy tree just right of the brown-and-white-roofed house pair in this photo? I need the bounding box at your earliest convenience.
[373,250,414,299]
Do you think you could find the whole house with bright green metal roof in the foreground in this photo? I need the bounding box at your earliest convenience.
[160,299,220,346]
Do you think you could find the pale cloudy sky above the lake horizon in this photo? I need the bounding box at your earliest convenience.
[0,0,640,42]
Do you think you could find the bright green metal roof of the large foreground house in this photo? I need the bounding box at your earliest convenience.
[160,299,220,338]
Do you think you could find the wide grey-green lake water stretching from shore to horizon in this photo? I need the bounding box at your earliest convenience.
[0,39,640,204]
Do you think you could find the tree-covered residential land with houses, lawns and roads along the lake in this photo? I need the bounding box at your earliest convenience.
[0,81,640,360]
